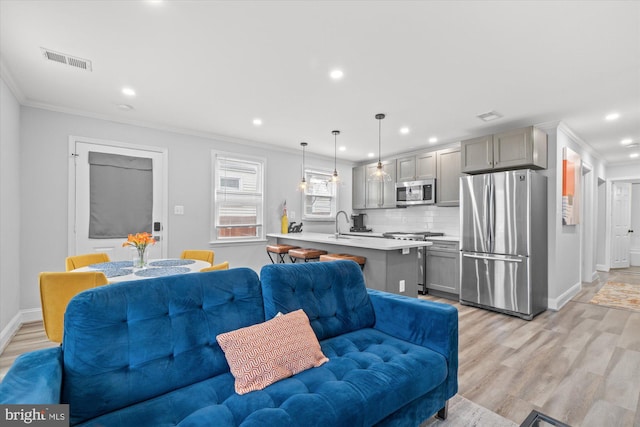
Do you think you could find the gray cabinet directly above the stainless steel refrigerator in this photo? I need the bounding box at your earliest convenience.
[461,126,547,173]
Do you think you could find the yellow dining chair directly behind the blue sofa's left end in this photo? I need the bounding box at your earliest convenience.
[40,271,108,343]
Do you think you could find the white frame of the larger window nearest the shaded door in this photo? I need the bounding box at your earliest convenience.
[209,150,267,244]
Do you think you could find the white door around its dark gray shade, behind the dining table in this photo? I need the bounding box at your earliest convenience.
[69,139,167,261]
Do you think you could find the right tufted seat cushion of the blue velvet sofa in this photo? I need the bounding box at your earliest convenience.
[172,329,447,427]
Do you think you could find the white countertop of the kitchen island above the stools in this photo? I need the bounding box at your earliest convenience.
[267,232,432,251]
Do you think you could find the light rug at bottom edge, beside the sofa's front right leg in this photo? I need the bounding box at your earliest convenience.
[420,394,518,427]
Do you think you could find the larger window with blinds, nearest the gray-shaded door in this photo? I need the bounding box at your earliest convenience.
[212,152,264,242]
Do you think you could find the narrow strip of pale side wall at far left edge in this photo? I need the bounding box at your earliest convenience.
[0,79,25,344]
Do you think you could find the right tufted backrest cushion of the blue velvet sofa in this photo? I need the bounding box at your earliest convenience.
[260,261,375,340]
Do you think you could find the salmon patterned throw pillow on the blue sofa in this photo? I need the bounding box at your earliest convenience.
[216,310,329,394]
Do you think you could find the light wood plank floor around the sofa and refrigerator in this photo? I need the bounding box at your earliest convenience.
[0,268,640,427]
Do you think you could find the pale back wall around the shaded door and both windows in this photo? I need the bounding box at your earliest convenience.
[17,107,352,309]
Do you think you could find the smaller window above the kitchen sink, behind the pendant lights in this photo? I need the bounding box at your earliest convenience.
[303,170,337,220]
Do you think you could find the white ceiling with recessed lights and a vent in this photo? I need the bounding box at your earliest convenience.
[0,0,640,165]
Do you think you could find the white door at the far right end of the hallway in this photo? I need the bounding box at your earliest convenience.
[611,182,631,268]
